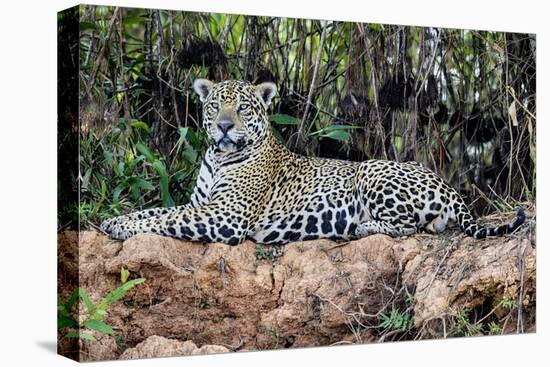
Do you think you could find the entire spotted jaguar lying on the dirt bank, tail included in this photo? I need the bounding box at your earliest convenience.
[102,79,525,245]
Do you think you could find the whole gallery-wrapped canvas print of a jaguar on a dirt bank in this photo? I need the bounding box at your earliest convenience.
[57,5,536,361]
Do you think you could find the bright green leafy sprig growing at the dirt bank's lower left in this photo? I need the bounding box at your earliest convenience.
[57,268,145,341]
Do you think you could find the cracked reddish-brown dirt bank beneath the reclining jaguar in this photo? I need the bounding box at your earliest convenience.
[59,216,536,360]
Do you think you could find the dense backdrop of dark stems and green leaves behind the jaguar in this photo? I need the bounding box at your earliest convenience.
[60,6,536,229]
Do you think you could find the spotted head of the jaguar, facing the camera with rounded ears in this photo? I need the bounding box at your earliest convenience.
[193,79,277,152]
